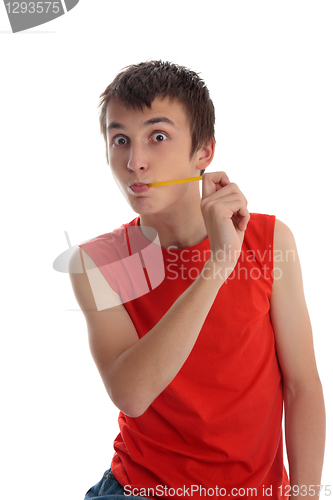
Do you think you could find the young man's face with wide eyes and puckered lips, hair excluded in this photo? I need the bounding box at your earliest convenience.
[106,99,207,214]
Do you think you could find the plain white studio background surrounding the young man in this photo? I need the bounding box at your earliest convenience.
[0,0,333,500]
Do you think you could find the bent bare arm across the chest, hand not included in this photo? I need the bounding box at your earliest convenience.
[70,246,226,417]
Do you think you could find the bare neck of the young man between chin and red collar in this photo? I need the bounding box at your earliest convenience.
[140,191,207,248]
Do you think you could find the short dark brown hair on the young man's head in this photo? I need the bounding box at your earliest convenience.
[98,61,215,171]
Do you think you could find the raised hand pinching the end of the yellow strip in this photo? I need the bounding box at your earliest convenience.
[201,172,250,274]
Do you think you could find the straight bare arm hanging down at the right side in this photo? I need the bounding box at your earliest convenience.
[271,220,325,500]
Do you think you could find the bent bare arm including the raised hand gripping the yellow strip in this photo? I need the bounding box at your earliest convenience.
[70,172,249,417]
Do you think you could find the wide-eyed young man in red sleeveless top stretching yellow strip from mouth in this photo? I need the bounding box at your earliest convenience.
[71,61,325,499]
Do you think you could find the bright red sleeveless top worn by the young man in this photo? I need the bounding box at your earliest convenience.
[80,214,288,499]
